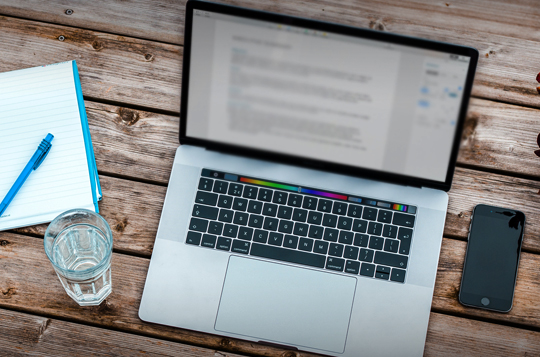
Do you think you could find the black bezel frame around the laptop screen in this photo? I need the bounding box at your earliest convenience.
[179,0,478,191]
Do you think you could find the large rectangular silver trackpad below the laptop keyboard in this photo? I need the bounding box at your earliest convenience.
[215,256,356,353]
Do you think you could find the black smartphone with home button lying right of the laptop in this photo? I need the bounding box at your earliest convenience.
[459,205,525,312]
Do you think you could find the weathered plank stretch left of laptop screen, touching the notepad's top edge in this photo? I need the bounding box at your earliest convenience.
[0,16,182,112]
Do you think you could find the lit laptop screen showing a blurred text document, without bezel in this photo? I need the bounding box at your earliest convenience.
[186,9,471,186]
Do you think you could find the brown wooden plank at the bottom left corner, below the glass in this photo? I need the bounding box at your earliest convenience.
[0,309,245,357]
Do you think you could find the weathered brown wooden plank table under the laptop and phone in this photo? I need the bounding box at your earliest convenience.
[0,0,540,356]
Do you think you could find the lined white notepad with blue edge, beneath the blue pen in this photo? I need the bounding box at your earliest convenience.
[0,61,102,230]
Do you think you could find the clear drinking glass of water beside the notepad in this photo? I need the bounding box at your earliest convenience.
[44,209,113,306]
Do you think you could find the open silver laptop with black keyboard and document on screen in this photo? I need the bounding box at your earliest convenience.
[139,1,478,356]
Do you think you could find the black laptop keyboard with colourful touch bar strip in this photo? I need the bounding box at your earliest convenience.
[186,169,416,283]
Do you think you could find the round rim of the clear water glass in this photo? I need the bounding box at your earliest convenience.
[43,208,113,277]
